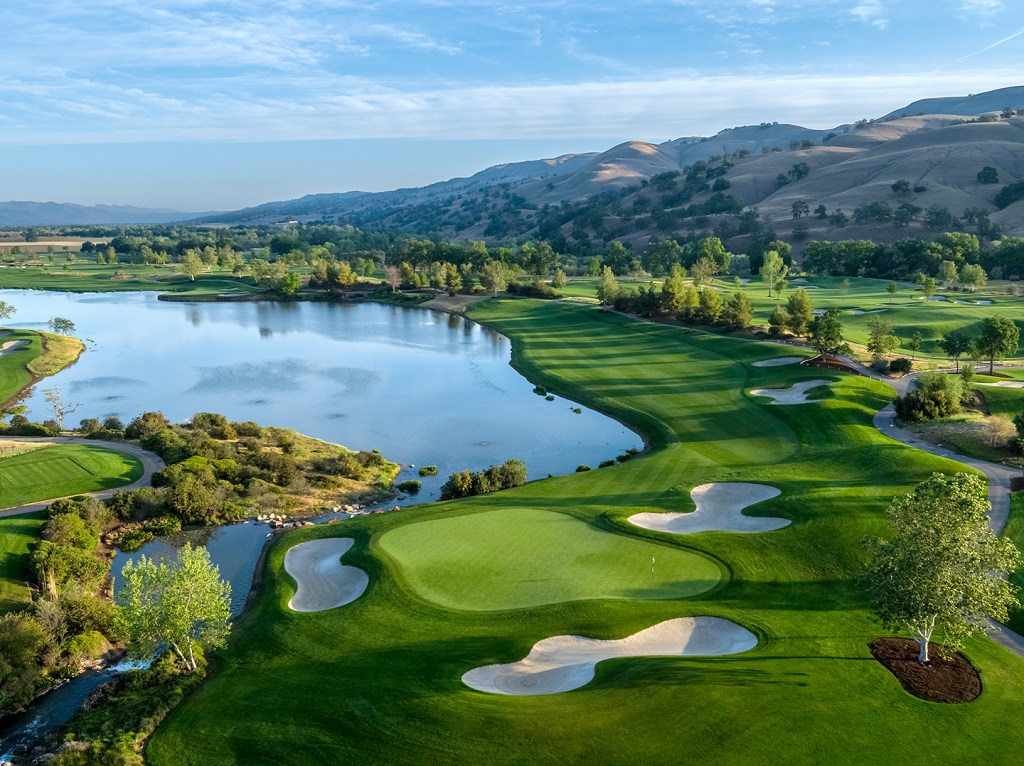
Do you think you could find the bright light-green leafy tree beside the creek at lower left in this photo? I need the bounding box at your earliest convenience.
[116,545,231,670]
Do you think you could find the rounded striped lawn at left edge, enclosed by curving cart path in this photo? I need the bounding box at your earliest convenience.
[0,444,143,508]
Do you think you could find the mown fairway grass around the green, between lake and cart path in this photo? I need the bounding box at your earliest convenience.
[147,300,1024,766]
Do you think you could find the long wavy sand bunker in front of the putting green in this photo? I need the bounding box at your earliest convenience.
[462,616,758,695]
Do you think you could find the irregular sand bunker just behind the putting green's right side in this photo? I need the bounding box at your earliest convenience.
[629,481,791,535]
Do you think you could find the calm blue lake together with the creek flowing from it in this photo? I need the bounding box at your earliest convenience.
[0,290,643,752]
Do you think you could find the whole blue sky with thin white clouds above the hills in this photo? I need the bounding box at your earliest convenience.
[0,0,1024,210]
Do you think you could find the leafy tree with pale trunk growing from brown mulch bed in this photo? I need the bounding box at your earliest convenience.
[862,473,1020,664]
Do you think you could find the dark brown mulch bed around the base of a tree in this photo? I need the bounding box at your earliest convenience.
[868,638,981,703]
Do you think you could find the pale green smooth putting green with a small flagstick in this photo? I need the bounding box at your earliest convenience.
[380,508,722,611]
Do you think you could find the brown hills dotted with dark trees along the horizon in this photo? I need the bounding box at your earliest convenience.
[0,86,1024,247]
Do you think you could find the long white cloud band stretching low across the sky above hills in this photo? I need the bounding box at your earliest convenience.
[0,70,1020,144]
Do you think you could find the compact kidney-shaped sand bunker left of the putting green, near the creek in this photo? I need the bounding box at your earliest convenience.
[285,538,370,611]
